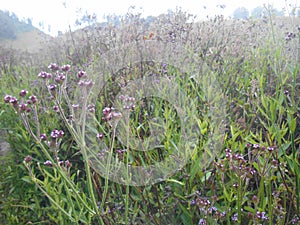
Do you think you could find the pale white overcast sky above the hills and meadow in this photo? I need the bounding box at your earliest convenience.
[0,0,300,36]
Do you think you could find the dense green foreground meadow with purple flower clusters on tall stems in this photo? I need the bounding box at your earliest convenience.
[0,10,300,225]
